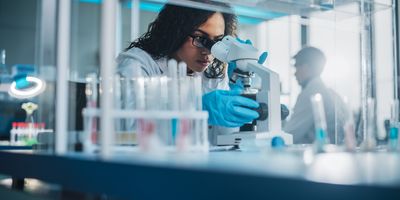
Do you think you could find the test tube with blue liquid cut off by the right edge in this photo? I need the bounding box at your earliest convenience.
[388,99,399,151]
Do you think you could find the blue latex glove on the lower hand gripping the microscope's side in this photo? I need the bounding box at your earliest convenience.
[203,89,259,127]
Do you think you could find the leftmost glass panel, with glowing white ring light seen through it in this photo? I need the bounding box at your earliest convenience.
[0,0,56,146]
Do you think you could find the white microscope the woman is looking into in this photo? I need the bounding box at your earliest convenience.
[211,36,293,145]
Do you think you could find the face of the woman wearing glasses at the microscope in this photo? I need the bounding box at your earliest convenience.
[174,13,225,72]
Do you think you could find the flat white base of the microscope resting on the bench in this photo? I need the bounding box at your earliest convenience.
[217,131,293,146]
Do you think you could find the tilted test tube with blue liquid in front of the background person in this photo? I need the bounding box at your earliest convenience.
[311,93,329,152]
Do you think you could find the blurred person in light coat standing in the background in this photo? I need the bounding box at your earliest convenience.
[284,47,348,144]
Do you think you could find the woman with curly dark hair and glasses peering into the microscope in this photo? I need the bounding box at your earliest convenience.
[117,2,259,144]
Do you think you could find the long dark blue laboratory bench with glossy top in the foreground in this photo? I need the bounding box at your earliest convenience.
[0,147,400,200]
